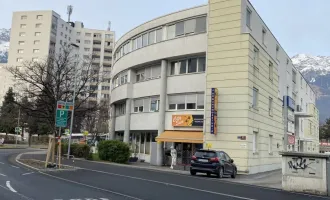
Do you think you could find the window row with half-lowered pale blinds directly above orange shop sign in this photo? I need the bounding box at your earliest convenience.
[168,93,204,110]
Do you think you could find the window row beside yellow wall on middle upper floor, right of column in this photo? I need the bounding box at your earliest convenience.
[170,57,206,75]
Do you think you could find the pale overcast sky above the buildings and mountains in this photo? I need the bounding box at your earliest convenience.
[0,0,330,56]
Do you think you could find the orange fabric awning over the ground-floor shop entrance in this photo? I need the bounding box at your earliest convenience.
[156,131,203,144]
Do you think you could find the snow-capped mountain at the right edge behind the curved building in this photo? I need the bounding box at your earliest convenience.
[291,54,330,122]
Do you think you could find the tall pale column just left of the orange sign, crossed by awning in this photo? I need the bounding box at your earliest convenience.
[156,60,167,165]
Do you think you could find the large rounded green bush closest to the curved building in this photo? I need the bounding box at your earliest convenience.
[98,140,131,163]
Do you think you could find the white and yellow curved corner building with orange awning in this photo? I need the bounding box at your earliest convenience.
[111,0,318,173]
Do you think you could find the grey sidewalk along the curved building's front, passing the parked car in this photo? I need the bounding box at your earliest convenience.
[20,151,282,189]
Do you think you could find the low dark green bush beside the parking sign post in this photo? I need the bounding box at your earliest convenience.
[56,143,90,159]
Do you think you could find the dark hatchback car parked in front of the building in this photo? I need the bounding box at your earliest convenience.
[190,149,237,178]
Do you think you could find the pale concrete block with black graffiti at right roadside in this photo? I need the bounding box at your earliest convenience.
[280,152,330,195]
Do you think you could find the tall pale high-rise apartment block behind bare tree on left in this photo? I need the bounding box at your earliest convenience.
[8,10,114,100]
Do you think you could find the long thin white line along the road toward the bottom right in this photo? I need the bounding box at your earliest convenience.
[69,168,255,200]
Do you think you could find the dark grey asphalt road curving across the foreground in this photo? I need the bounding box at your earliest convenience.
[0,150,328,200]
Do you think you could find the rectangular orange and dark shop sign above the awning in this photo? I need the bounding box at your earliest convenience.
[172,115,204,127]
